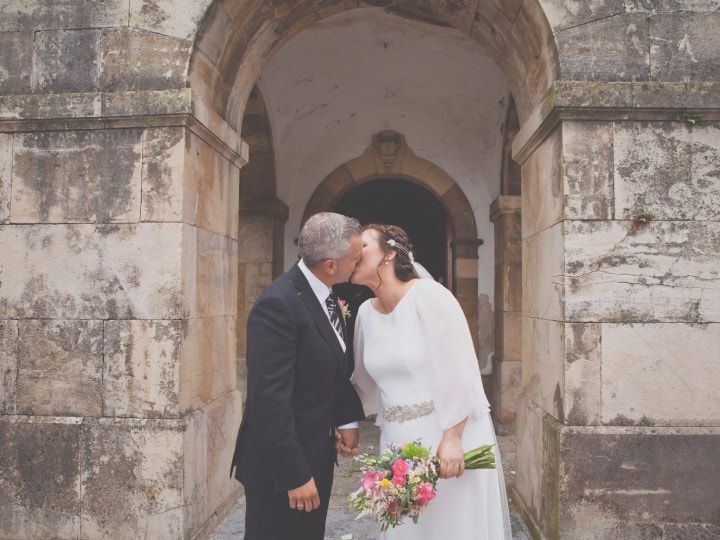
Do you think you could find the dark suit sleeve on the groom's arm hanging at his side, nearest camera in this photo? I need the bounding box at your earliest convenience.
[247,296,312,491]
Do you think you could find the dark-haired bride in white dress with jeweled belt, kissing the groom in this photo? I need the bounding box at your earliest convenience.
[352,224,512,540]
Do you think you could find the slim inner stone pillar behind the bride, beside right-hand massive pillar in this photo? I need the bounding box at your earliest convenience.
[488,195,522,433]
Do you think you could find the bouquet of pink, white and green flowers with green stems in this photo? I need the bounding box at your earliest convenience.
[348,441,495,531]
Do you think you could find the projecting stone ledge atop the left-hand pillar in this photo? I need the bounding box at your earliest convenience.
[0,88,249,168]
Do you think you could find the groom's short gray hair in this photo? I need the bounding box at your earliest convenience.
[298,212,362,266]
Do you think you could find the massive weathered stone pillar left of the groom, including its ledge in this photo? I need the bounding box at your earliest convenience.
[0,89,247,538]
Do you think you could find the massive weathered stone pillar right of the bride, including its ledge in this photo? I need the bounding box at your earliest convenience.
[514,82,720,538]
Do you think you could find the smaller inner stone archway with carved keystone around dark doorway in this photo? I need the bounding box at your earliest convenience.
[303,130,480,350]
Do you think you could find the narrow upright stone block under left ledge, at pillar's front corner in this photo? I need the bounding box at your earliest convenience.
[141,128,186,222]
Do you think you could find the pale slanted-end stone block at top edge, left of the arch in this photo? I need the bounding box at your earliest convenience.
[130,0,212,41]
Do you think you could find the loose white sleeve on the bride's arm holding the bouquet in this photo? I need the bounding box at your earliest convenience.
[415,280,489,431]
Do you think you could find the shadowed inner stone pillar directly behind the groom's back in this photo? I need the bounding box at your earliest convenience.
[237,198,289,392]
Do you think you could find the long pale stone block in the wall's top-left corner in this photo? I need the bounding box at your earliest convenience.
[0,0,128,31]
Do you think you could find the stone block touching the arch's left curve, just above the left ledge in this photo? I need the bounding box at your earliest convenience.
[100,28,192,92]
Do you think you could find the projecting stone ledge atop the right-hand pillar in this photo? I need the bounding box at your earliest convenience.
[512,81,720,164]
